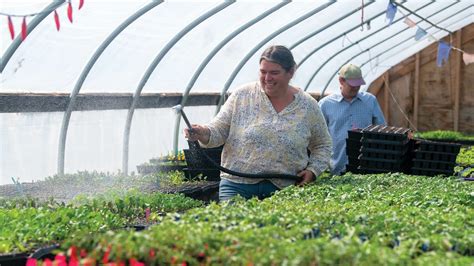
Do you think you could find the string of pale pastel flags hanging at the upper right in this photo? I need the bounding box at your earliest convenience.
[385,0,474,67]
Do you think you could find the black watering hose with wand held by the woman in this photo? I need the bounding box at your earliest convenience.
[172,104,302,182]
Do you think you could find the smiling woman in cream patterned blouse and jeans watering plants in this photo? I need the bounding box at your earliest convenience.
[185,45,332,201]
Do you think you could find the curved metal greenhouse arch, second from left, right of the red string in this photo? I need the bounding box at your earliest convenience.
[57,0,163,175]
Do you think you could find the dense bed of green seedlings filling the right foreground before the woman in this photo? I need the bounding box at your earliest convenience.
[52,174,474,265]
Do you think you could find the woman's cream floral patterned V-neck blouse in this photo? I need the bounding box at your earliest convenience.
[201,82,332,189]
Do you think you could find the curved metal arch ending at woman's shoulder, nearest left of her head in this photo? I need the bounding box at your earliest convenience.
[216,0,336,113]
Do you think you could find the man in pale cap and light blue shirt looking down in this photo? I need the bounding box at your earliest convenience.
[319,64,385,175]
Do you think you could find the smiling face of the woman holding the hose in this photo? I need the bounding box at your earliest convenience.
[260,60,294,96]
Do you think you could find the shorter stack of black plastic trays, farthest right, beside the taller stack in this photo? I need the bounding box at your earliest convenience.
[411,140,461,176]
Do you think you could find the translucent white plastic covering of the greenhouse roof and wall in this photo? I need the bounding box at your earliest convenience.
[0,0,474,184]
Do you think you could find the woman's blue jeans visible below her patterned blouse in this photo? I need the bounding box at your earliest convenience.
[219,179,279,201]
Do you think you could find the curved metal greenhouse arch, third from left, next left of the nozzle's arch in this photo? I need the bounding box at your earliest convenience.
[122,0,236,174]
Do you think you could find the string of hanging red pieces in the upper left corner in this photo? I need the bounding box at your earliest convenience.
[0,0,84,41]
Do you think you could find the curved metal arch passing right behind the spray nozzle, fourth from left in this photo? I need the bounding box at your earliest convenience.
[173,0,291,154]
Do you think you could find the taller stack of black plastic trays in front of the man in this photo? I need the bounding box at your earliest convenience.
[359,125,413,173]
